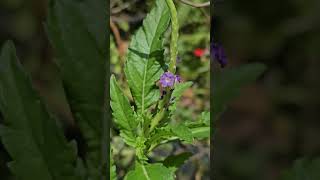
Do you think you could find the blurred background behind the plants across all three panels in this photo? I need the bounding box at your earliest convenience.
[0,0,320,180]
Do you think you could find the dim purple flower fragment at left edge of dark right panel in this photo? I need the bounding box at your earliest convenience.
[210,42,228,68]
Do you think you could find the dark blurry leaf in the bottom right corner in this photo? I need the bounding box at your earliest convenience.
[281,158,320,180]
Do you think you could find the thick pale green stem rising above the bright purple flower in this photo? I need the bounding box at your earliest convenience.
[166,0,179,74]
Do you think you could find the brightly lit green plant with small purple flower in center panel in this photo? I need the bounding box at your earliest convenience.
[110,0,210,180]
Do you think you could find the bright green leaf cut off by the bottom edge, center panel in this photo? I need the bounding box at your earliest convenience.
[124,163,174,180]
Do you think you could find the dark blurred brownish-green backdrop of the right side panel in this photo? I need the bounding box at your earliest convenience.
[213,0,320,180]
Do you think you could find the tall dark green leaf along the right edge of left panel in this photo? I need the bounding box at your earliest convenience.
[46,0,109,179]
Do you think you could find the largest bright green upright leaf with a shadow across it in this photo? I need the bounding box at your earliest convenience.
[124,0,170,114]
